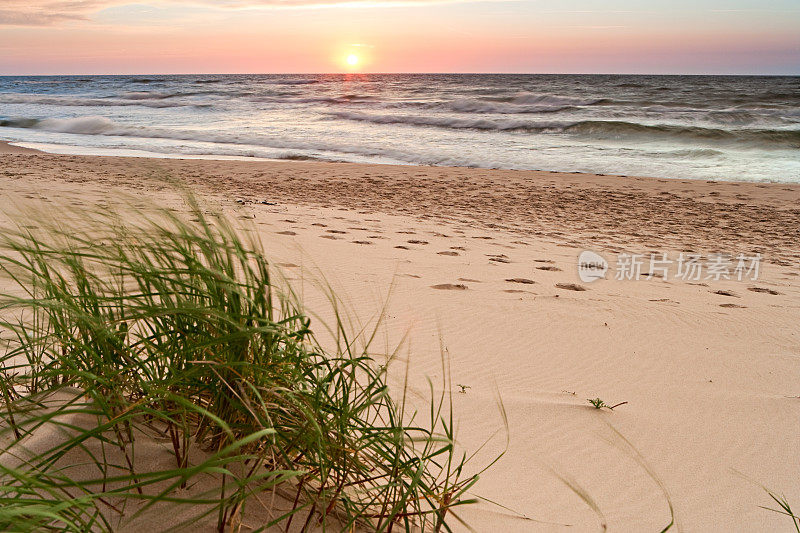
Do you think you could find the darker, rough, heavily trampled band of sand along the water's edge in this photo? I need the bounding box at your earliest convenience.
[0,145,800,266]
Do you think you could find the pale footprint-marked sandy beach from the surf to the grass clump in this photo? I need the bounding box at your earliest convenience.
[0,147,800,531]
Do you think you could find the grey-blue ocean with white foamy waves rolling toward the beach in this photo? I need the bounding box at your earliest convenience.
[0,74,800,182]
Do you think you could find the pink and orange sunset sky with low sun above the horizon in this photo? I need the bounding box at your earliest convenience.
[0,0,800,75]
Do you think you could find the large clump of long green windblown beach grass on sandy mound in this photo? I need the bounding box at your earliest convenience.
[0,198,478,531]
